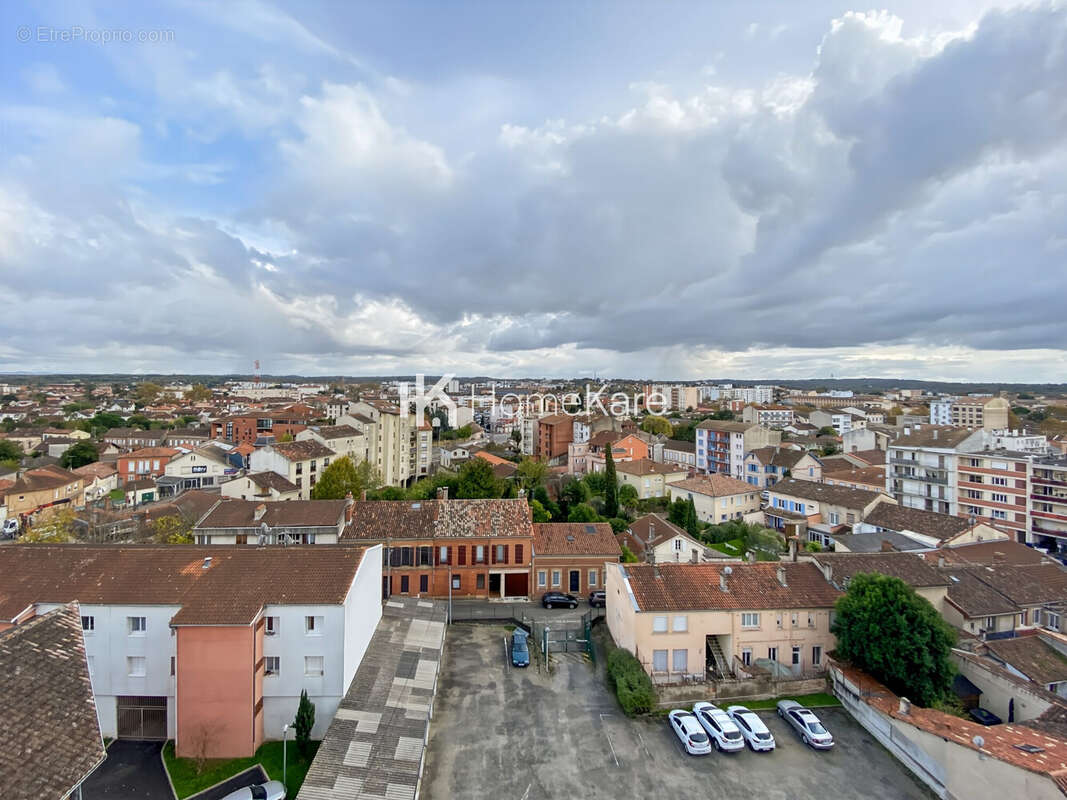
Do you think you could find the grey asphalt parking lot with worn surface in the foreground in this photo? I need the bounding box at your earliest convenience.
[423,625,931,800]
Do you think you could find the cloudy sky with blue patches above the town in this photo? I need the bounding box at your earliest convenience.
[0,0,1067,382]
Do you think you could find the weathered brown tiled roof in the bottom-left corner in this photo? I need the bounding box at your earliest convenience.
[0,605,106,800]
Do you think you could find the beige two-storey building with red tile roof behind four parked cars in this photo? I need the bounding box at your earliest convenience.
[606,562,841,683]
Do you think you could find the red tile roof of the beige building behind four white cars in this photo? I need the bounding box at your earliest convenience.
[624,562,841,611]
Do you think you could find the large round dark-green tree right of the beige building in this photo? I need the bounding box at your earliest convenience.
[830,573,956,706]
